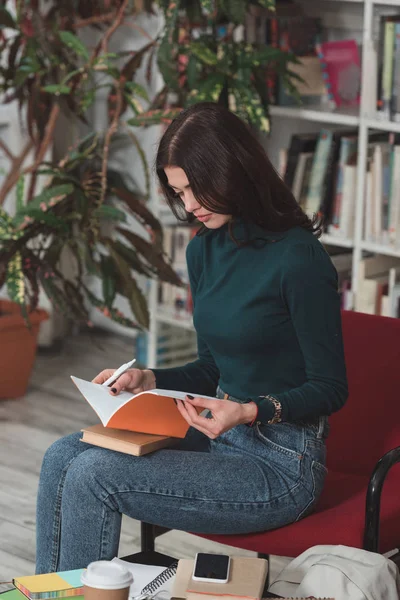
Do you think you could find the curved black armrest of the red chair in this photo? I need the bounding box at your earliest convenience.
[363,446,400,552]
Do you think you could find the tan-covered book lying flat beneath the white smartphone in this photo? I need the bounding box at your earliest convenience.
[171,556,268,600]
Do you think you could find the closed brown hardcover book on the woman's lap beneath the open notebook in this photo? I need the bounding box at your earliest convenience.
[81,425,178,456]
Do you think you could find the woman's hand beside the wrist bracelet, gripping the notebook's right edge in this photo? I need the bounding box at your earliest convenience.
[176,396,257,440]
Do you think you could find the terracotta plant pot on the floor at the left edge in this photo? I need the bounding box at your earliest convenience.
[0,300,49,399]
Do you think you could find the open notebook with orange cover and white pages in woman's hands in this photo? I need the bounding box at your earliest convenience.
[71,377,215,438]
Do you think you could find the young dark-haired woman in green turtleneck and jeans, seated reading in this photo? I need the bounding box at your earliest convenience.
[37,103,347,573]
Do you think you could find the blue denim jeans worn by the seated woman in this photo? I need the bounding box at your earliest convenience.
[36,389,327,573]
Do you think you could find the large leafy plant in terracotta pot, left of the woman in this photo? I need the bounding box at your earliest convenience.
[0,0,181,397]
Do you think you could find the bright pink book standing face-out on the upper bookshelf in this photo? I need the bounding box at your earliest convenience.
[317,40,361,107]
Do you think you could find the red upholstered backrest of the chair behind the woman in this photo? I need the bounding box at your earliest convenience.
[327,311,400,475]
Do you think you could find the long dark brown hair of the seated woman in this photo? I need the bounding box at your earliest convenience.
[156,102,321,237]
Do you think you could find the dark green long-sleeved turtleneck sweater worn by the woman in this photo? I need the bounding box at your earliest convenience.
[153,222,347,422]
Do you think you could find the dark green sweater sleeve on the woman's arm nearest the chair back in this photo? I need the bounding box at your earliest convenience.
[248,244,348,422]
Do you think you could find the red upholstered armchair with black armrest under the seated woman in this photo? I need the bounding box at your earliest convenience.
[142,311,400,557]
